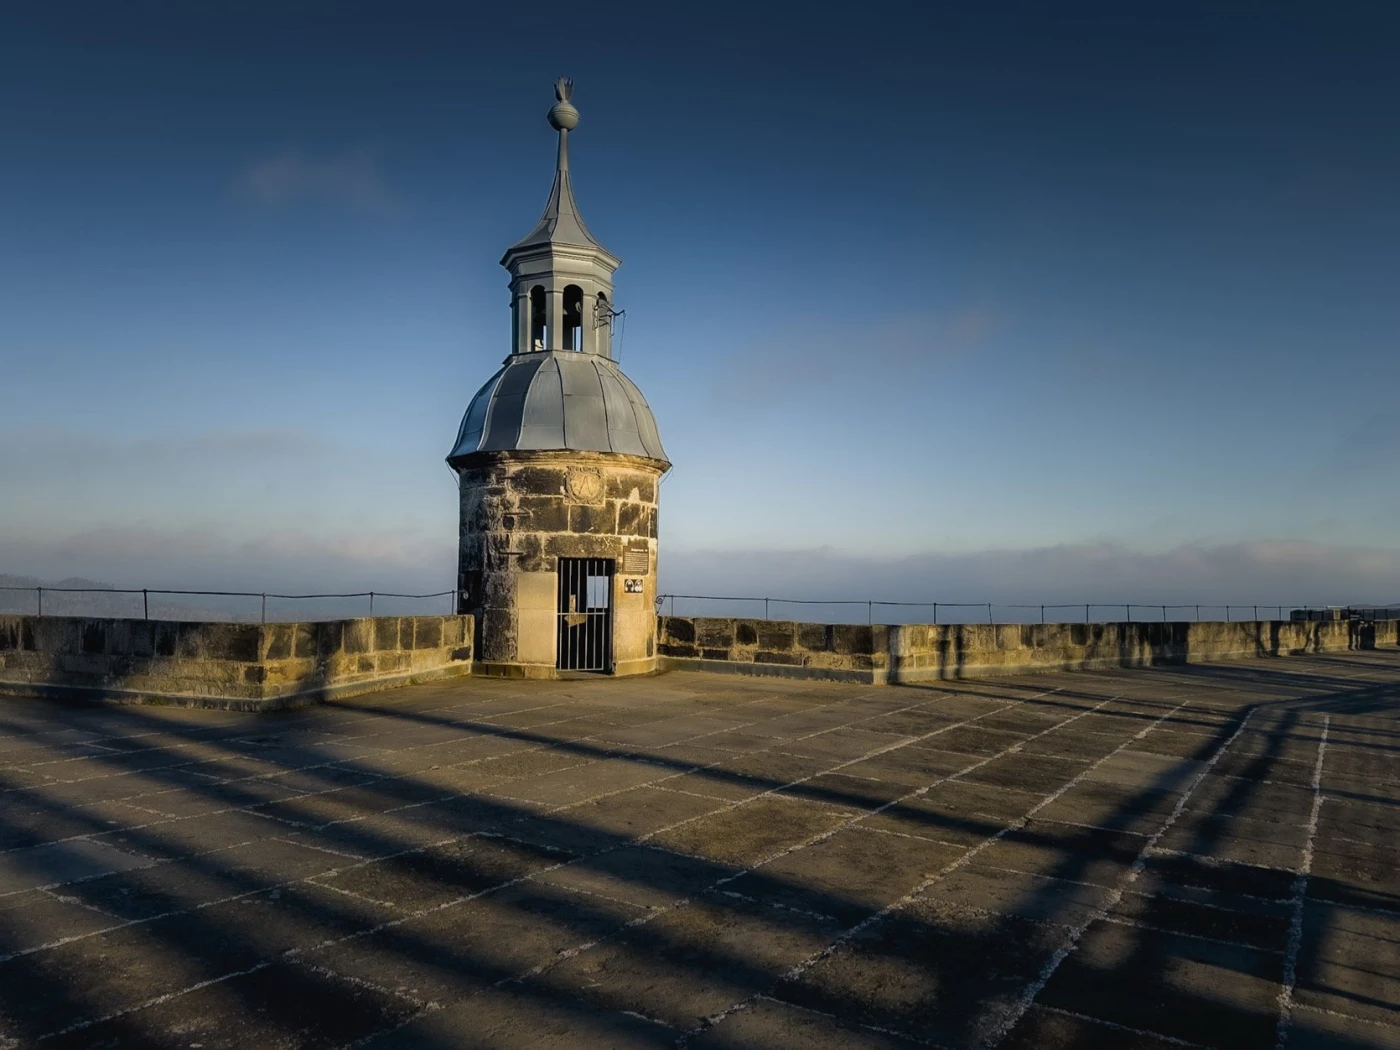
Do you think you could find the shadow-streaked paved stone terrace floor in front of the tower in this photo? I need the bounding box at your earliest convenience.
[0,652,1400,1050]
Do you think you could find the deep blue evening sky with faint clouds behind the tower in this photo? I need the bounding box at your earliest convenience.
[0,0,1400,602]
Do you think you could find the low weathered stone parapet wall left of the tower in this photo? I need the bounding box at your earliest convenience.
[0,616,472,710]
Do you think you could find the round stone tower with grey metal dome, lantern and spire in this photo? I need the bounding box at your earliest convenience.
[447,77,671,678]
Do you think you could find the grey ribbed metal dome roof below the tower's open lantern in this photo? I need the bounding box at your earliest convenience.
[448,350,666,463]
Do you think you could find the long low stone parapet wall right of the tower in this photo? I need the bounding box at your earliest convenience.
[658,616,1400,683]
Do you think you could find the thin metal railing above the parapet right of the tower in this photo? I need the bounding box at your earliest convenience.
[657,594,1377,624]
